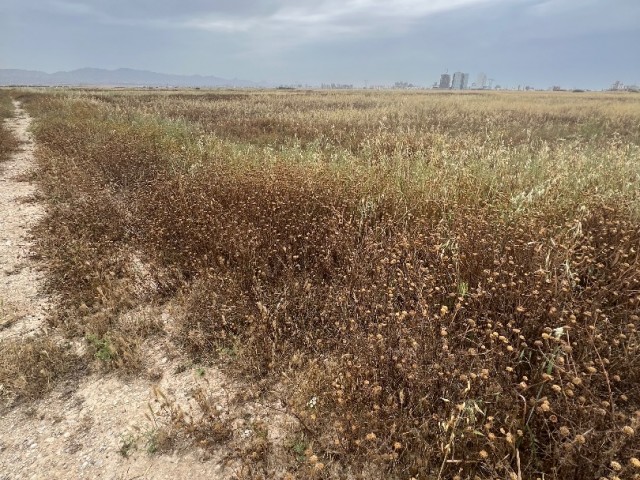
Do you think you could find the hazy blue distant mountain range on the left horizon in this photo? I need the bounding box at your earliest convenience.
[0,68,267,87]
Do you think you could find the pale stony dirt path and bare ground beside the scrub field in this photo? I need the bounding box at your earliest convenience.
[0,103,292,480]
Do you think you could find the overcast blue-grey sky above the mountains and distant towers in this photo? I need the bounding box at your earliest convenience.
[0,0,640,89]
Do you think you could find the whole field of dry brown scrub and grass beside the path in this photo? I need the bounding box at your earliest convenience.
[7,91,640,479]
